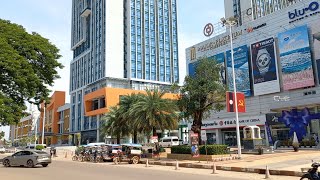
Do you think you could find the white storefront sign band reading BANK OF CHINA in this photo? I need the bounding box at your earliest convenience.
[201,115,266,129]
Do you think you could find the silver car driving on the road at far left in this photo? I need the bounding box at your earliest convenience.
[3,150,51,168]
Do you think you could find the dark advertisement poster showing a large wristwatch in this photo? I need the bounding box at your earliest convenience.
[251,38,280,96]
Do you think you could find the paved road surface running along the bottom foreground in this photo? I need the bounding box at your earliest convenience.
[0,160,298,180]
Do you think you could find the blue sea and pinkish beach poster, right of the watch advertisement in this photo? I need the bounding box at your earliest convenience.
[278,25,314,90]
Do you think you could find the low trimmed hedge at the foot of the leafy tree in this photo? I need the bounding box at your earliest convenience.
[171,144,229,155]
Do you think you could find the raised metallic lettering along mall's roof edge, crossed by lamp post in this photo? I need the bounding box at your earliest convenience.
[197,30,242,52]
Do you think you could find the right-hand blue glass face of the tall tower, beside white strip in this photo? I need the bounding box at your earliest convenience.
[124,0,179,83]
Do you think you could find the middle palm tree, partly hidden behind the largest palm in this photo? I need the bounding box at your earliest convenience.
[119,94,142,143]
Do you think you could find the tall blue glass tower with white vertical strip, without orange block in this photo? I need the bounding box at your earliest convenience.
[70,0,179,141]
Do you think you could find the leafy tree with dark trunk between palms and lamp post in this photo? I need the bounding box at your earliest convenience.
[177,58,226,143]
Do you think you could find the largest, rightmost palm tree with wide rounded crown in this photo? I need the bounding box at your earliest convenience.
[129,90,178,136]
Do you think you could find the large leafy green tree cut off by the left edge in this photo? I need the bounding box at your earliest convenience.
[0,19,63,125]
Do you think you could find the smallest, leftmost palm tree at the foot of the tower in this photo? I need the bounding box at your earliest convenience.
[100,106,130,144]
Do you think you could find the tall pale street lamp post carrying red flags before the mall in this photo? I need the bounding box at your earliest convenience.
[221,17,241,158]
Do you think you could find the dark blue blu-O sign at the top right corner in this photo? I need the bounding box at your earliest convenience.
[288,1,320,23]
